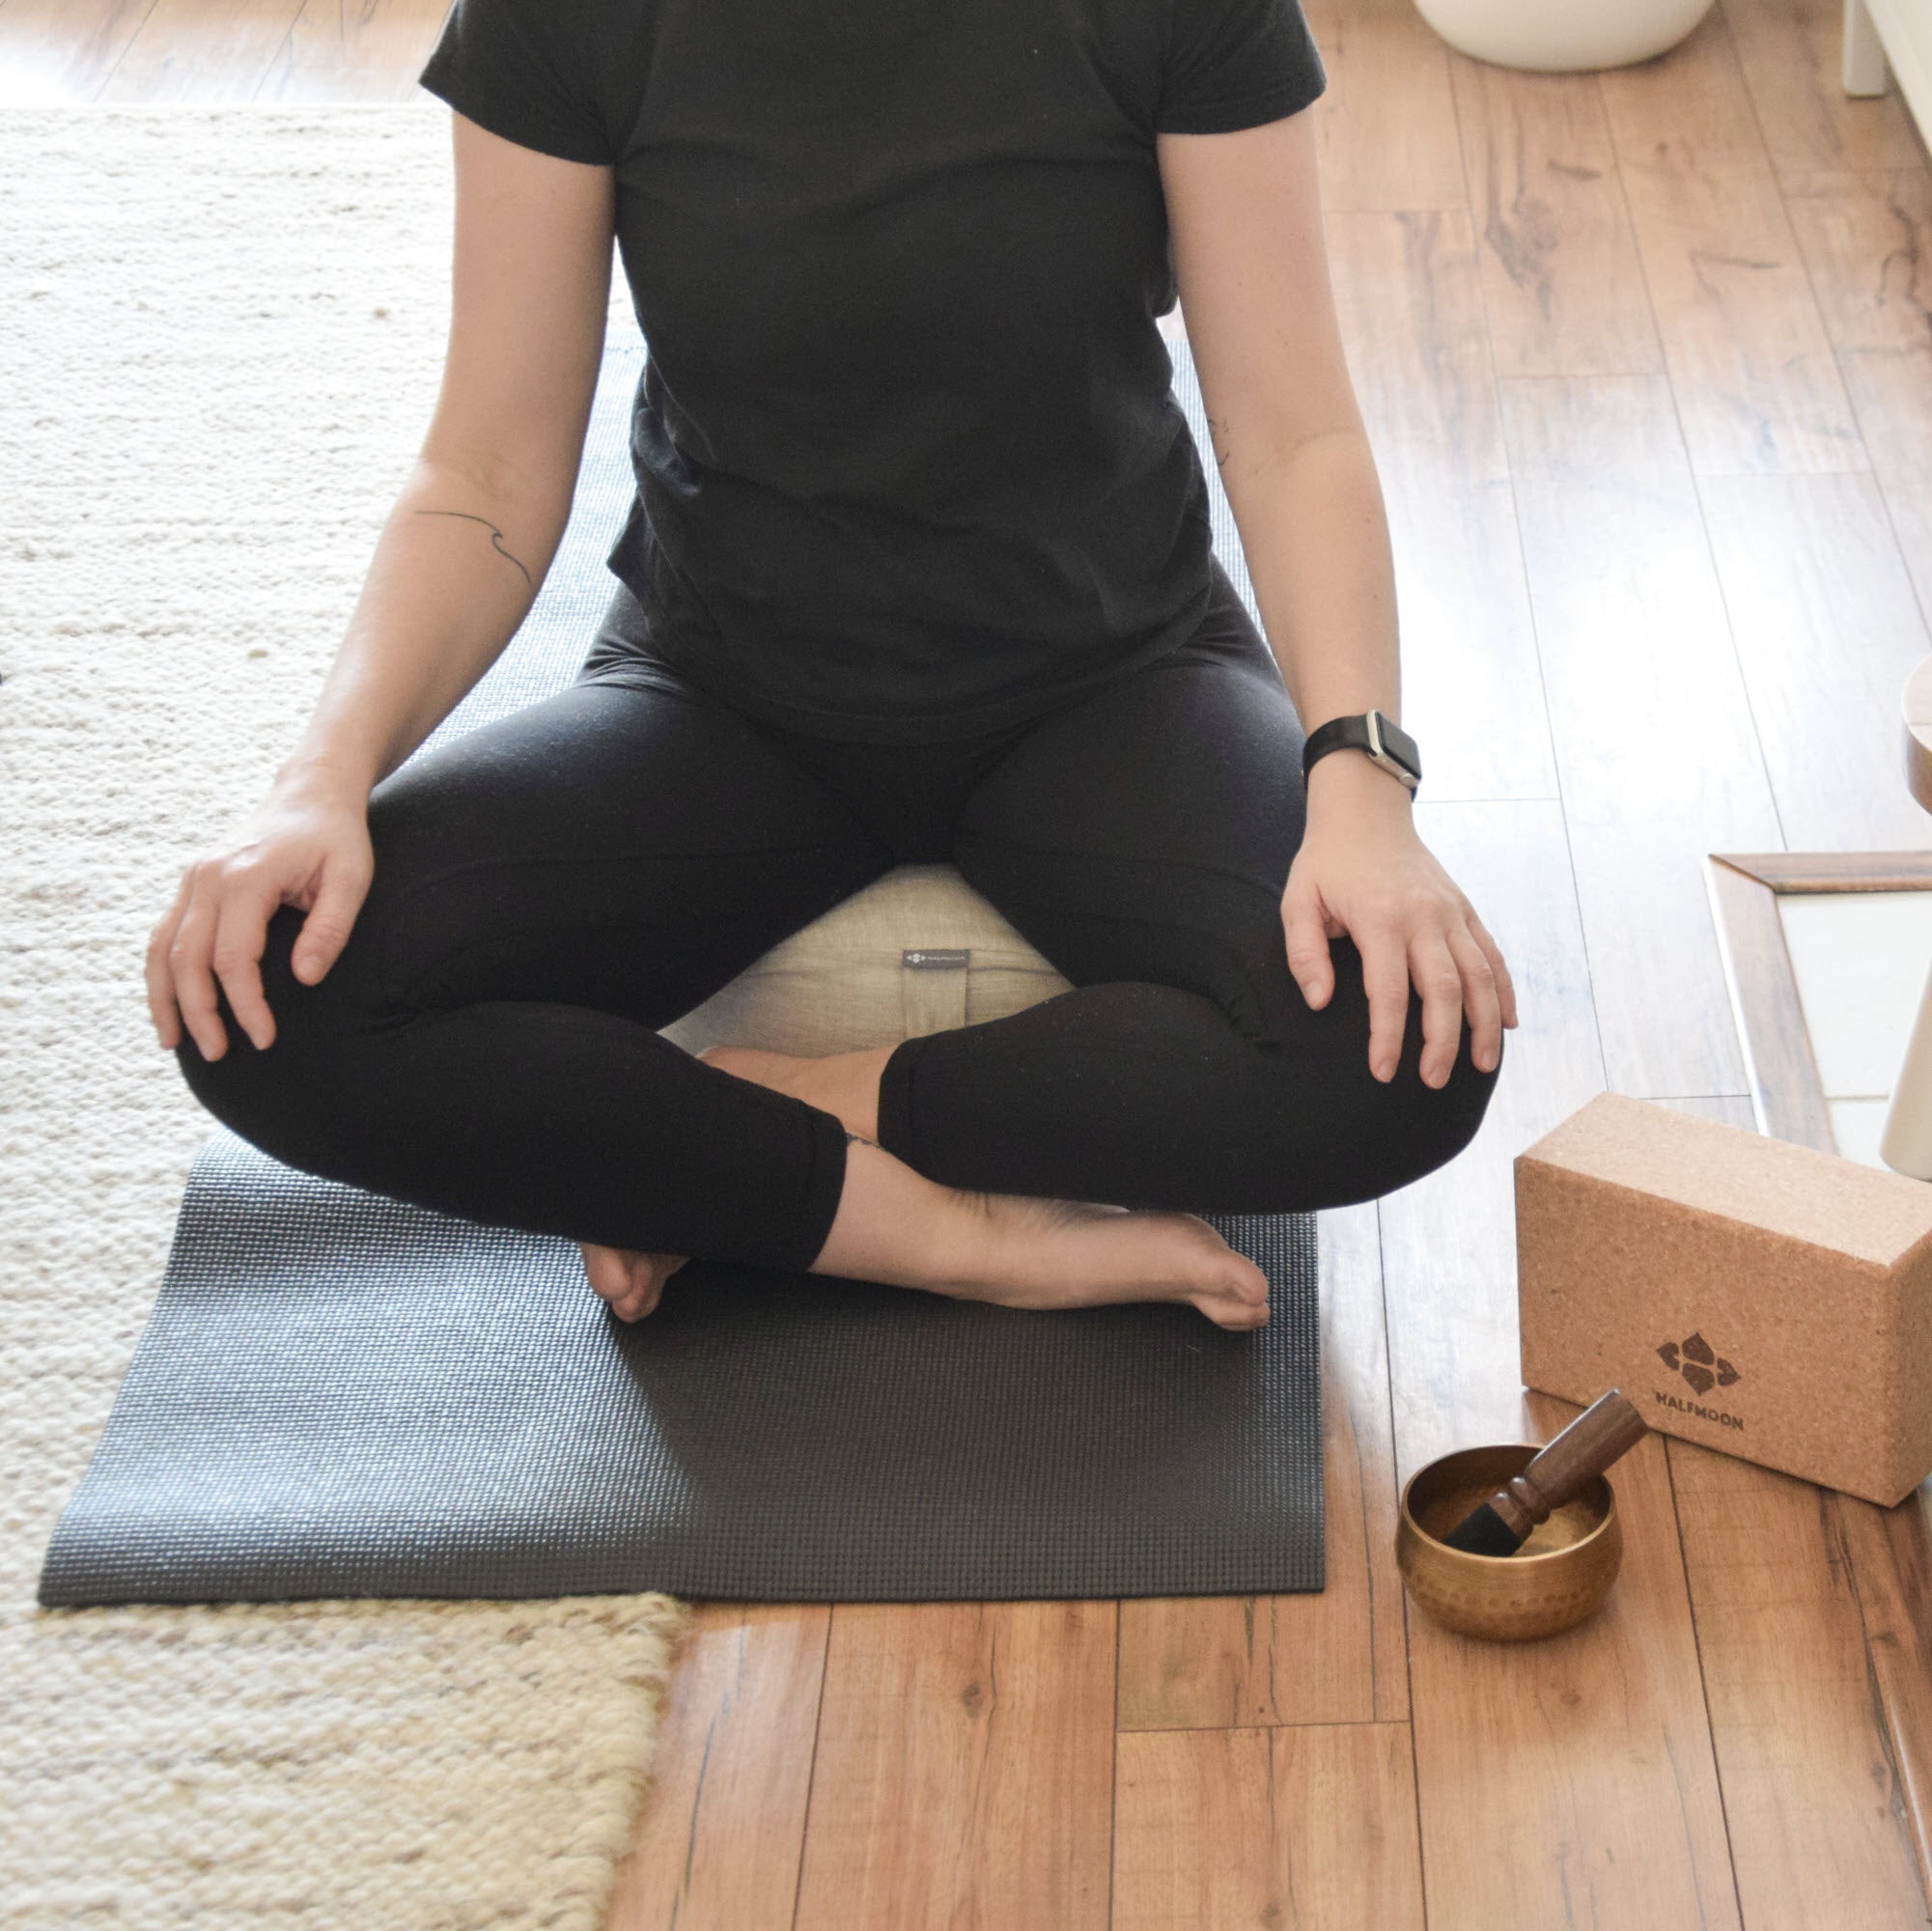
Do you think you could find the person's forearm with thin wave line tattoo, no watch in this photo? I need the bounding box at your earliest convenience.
[276,462,570,794]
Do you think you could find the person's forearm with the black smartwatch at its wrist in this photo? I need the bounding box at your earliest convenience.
[1221,431,1409,823]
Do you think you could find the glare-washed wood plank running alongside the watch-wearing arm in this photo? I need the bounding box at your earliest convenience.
[1328,209,1555,799]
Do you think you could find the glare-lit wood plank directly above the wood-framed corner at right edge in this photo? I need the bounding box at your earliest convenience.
[1698,471,1932,852]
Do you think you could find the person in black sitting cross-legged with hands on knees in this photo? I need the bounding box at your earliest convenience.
[147,0,1517,1329]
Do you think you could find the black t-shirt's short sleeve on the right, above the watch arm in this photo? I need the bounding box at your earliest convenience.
[1154,0,1328,133]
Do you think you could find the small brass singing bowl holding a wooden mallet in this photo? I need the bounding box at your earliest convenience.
[1395,1442,1623,1643]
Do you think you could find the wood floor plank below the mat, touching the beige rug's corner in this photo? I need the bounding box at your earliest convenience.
[606,1603,830,1931]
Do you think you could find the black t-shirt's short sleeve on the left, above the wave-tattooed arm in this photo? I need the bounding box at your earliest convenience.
[417,0,616,164]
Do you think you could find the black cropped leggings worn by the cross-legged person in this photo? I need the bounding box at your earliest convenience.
[178,566,1498,1269]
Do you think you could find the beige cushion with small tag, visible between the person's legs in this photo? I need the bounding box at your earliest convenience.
[664,865,1069,1056]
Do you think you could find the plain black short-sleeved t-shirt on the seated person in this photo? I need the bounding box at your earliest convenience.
[421,0,1328,742]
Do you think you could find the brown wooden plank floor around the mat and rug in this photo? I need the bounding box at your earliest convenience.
[22,0,1932,1931]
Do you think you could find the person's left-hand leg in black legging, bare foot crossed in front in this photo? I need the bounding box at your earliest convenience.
[178,664,1266,1325]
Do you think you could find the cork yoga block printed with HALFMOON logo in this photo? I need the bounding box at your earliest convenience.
[1515,1093,1932,1506]
